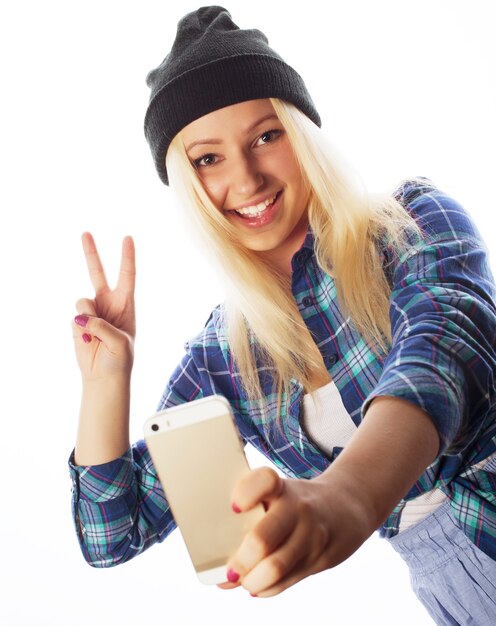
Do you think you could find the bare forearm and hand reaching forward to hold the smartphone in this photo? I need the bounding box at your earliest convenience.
[228,396,440,597]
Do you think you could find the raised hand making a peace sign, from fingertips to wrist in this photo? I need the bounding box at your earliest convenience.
[73,233,136,382]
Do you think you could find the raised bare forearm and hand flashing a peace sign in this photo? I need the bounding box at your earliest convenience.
[72,233,136,465]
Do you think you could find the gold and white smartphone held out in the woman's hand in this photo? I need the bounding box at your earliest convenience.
[144,396,264,584]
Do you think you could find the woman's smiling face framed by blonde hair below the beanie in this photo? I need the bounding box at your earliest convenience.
[181,100,309,272]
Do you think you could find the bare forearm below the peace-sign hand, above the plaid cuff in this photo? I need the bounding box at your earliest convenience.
[74,377,130,465]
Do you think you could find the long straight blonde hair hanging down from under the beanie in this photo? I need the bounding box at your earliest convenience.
[167,99,420,402]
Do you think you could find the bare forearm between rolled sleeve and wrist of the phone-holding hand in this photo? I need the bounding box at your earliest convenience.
[317,396,440,532]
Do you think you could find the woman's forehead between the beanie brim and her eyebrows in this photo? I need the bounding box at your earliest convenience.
[180,99,277,148]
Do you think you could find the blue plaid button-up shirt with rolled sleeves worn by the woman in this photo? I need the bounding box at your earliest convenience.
[69,179,496,567]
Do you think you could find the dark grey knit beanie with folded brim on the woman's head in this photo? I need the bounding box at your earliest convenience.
[145,6,320,185]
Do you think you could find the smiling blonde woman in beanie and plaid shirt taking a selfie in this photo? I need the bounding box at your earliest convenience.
[70,7,496,625]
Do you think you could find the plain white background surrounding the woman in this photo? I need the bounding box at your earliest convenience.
[0,0,496,626]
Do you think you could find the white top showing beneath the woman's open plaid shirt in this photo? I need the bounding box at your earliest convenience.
[303,381,447,532]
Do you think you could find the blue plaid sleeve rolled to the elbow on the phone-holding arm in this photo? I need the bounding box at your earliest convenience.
[362,187,496,454]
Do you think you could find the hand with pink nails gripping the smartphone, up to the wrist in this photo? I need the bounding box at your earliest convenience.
[224,467,373,597]
